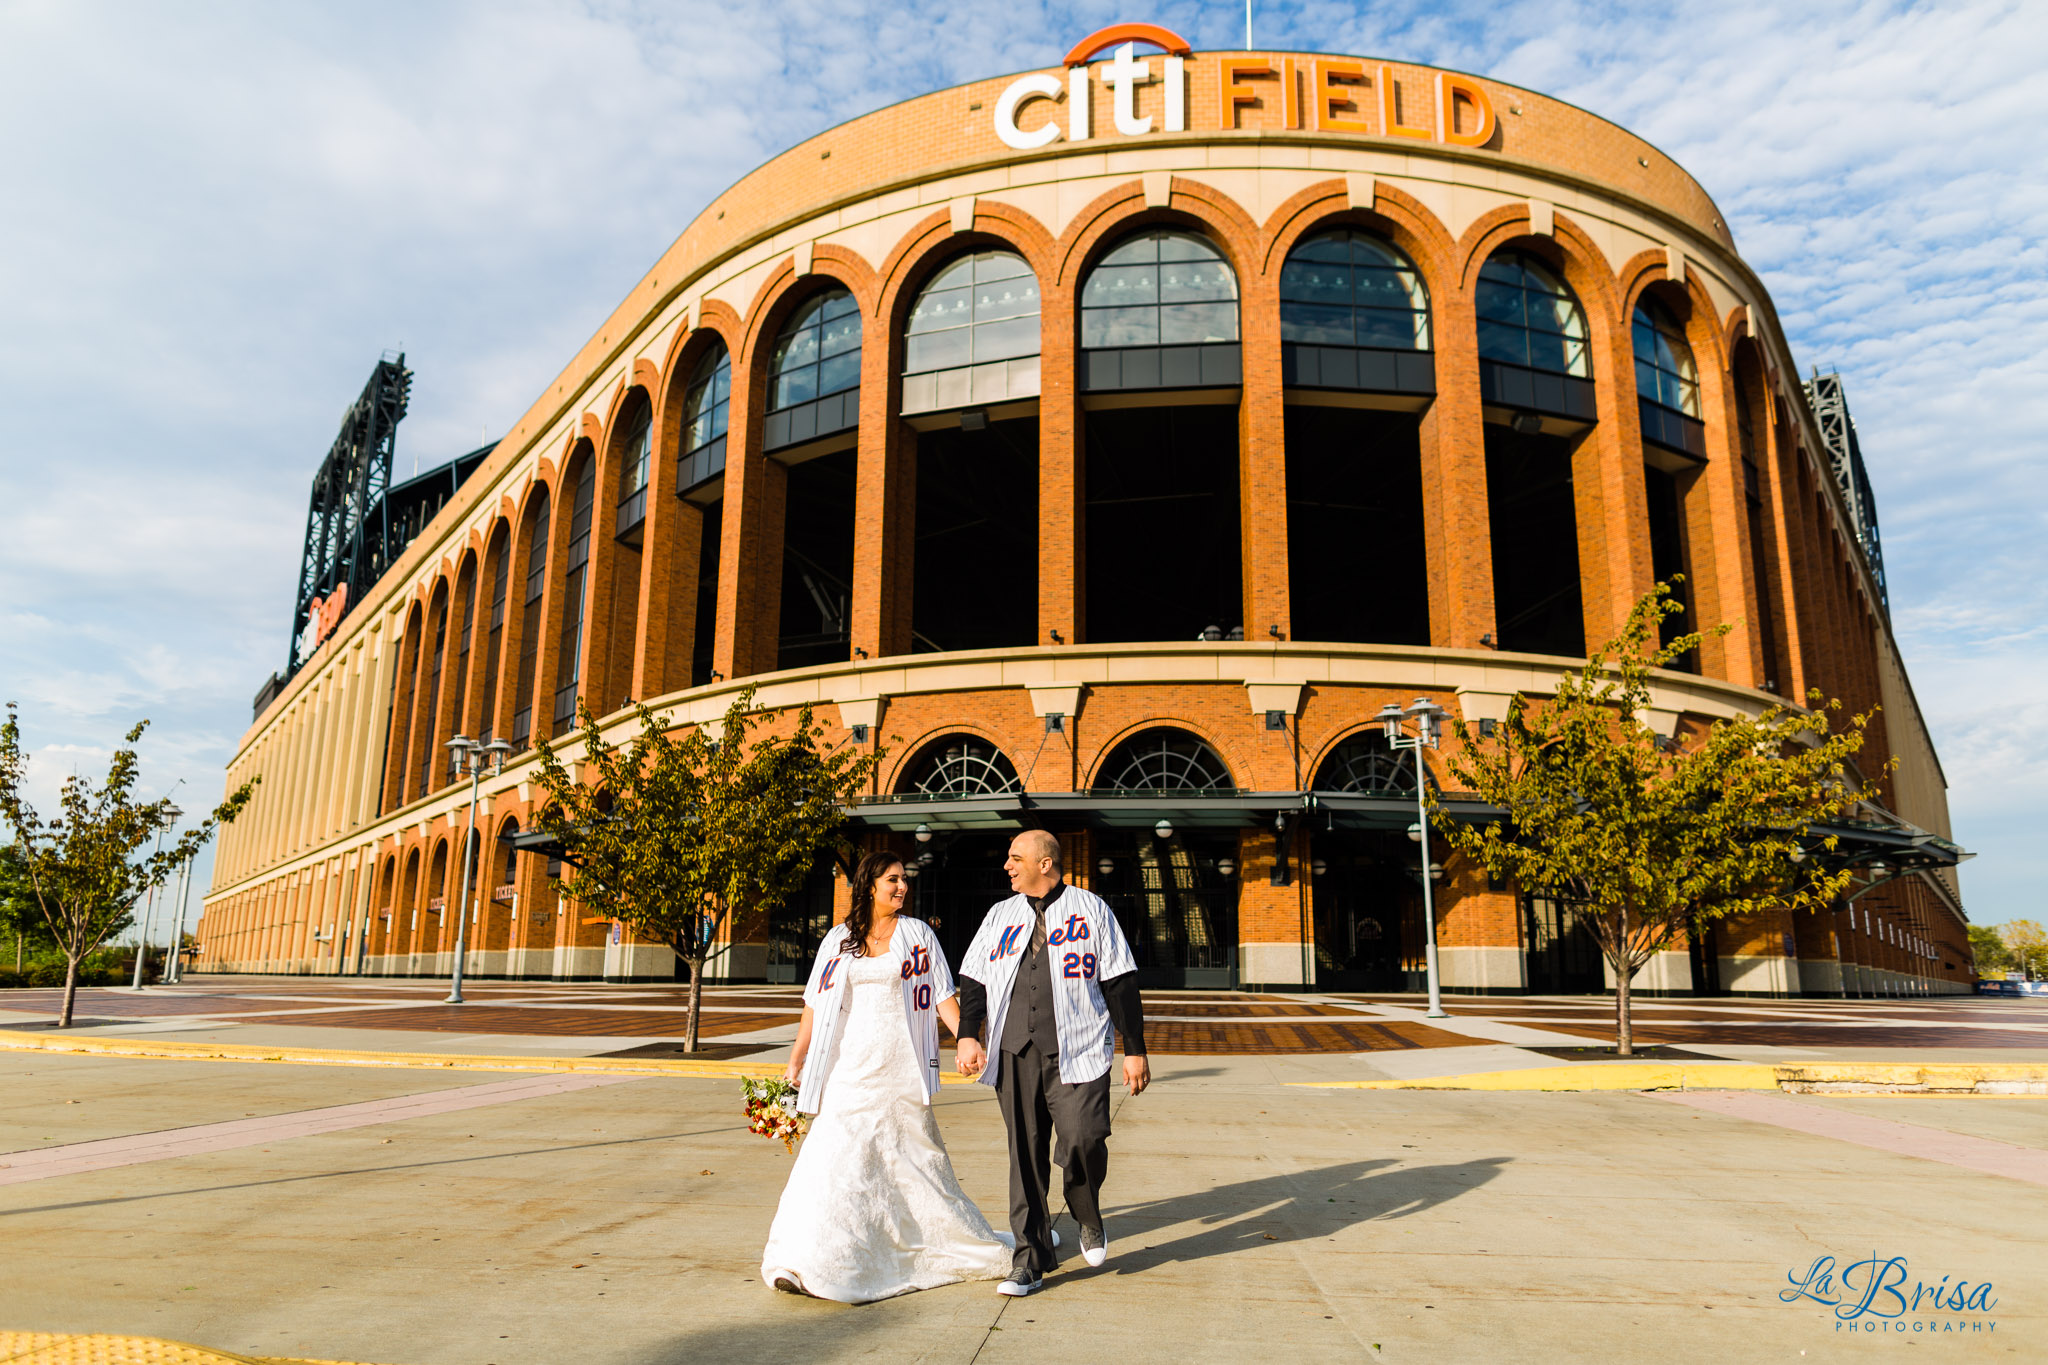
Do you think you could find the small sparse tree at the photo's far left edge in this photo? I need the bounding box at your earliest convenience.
[0,702,256,1029]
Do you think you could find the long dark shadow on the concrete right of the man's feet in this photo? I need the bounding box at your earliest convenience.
[1089,1156,1513,1275]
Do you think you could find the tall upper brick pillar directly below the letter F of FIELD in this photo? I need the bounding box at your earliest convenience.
[1225,259,1298,642]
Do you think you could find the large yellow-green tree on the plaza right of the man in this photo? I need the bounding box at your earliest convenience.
[1430,583,1872,1056]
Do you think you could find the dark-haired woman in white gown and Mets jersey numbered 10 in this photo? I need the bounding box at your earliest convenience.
[762,853,1010,1304]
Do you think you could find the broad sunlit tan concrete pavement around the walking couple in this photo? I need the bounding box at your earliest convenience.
[0,1052,2048,1365]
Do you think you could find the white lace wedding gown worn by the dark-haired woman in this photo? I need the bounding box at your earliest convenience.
[762,954,1010,1304]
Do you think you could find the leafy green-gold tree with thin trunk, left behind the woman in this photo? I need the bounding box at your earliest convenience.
[537,688,881,1052]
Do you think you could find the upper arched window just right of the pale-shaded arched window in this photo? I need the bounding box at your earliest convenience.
[1081,229,1243,389]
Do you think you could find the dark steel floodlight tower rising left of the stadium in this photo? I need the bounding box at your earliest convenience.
[285,352,412,677]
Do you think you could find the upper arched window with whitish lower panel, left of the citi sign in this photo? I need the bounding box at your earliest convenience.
[903,252,1038,413]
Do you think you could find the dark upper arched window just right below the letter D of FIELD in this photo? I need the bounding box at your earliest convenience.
[1473,252,1595,422]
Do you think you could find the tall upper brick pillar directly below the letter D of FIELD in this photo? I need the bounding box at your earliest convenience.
[1417,280,1495,649]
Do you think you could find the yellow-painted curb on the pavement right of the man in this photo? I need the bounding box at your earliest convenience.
[1288,1062,2048,1095]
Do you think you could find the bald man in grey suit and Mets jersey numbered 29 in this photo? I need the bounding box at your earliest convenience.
[958,829,1151,1295]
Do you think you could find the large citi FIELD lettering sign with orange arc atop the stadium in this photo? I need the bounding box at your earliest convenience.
[993,25,1499,151]
